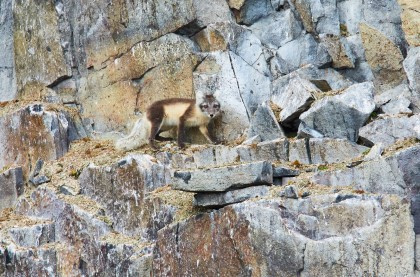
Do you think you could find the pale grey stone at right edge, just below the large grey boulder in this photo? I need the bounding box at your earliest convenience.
[360,115,420,147]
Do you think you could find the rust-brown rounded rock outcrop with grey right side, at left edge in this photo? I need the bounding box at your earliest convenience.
[0,104,86,178]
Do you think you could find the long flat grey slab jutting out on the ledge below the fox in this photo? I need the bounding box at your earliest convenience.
[171,162,273,192]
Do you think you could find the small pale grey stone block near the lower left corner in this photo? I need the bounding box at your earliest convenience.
[9,224,55,247]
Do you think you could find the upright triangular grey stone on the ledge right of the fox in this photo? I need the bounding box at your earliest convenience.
[247,102,285,141]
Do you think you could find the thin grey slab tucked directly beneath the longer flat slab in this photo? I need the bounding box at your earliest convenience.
[194,186,268,207]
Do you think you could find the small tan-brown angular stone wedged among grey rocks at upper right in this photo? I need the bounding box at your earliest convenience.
[320,34,356,68]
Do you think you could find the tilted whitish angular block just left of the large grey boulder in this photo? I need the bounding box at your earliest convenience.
[271,73,321,125]
